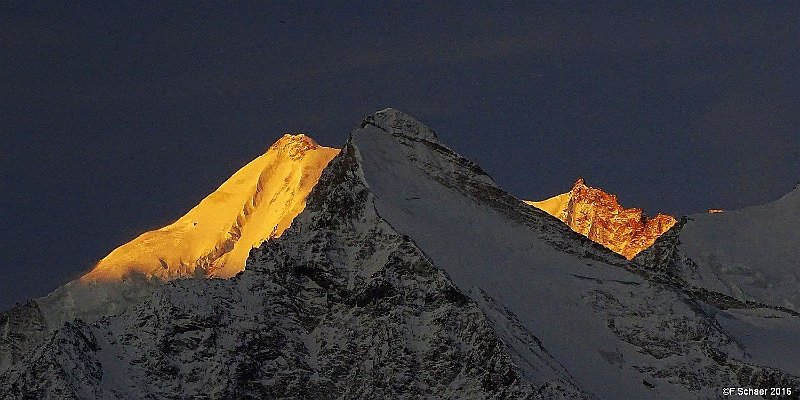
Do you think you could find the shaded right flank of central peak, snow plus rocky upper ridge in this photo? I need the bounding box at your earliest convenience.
[351,110,796,398]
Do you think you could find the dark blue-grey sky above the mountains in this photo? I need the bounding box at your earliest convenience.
[0,1,800,308]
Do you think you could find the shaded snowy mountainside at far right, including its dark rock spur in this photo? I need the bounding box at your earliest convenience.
[635,187,800,375]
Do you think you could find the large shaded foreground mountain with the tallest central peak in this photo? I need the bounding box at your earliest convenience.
[0,109,800,399]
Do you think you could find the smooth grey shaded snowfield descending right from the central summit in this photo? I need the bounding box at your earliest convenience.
[351,110,768,398]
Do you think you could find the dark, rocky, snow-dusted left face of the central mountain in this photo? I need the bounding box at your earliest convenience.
[0,117,588,399]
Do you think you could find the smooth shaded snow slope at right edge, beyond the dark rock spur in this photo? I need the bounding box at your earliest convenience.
[678,187,800,312]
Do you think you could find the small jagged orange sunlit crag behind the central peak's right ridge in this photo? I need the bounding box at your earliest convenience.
[525,179,676,260]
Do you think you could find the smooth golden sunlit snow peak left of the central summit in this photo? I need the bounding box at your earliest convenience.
[80,134,339,283]
